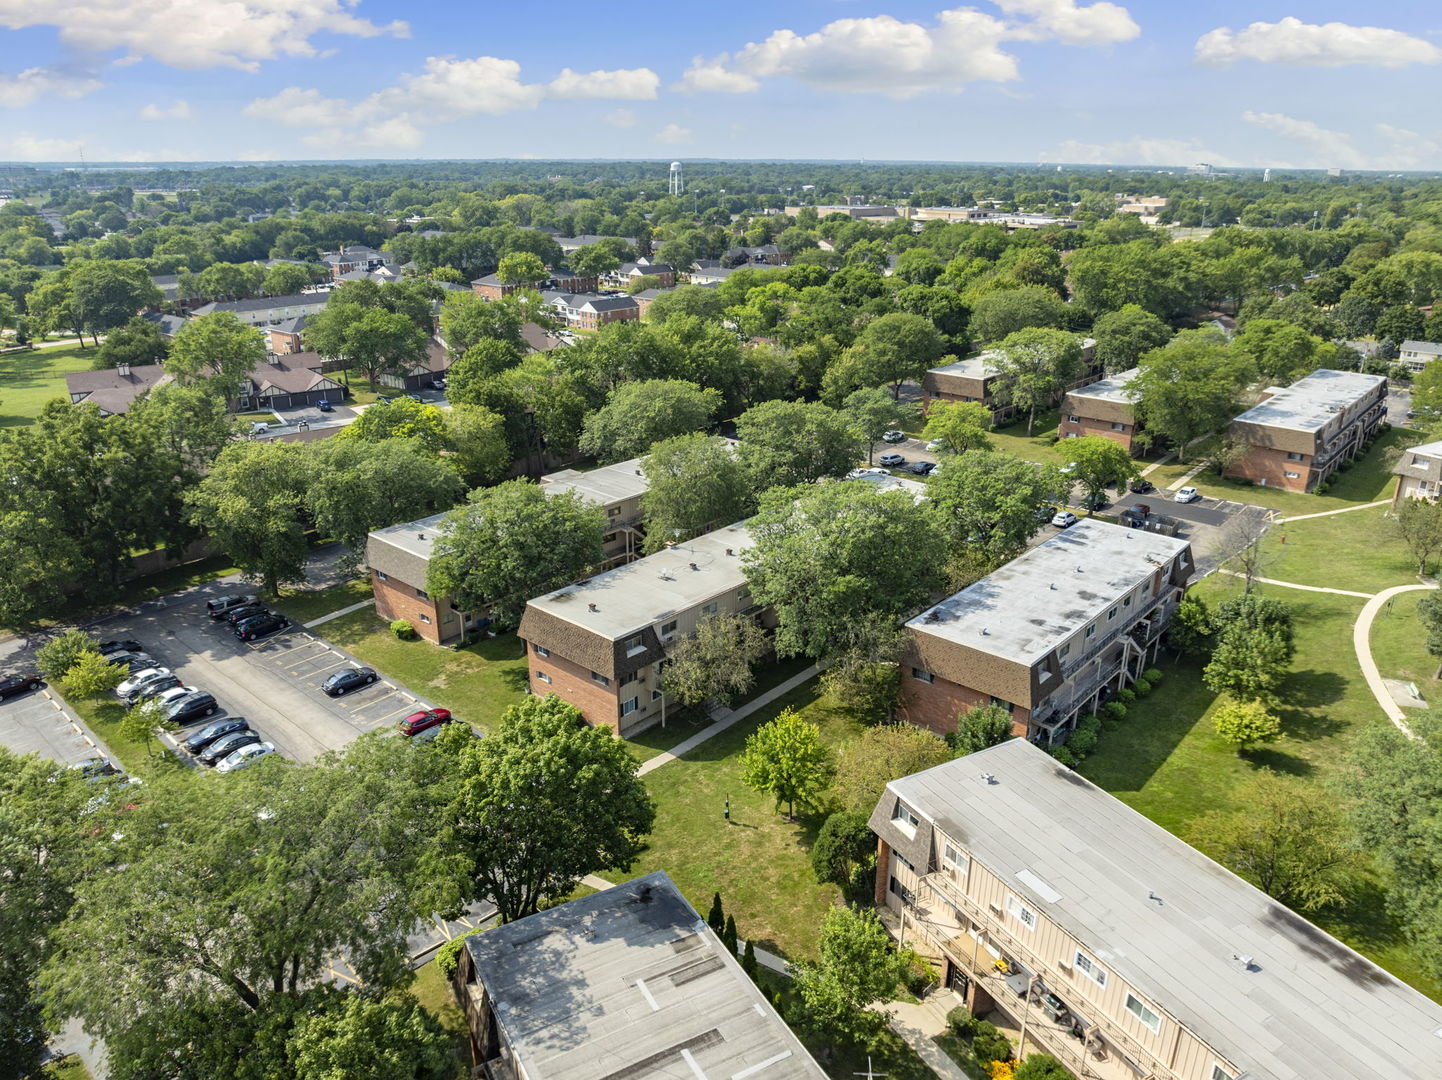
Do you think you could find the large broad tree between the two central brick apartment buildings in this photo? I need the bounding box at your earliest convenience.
[741,483,946,658]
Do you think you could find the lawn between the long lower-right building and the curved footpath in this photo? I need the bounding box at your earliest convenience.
[1080,577,1442,999]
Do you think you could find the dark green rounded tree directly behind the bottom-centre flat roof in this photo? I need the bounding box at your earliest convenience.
[444,696,656,923]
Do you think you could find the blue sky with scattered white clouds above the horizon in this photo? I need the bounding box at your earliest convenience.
[0,0,1442,169]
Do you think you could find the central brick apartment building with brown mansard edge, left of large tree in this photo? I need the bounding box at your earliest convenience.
[518,522,756,735]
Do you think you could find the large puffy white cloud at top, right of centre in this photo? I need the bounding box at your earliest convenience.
[675,0,1141,98]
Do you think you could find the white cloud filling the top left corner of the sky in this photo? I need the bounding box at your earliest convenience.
[0,0,410,71]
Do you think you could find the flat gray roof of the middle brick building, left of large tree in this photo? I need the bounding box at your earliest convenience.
[531,522,751,639]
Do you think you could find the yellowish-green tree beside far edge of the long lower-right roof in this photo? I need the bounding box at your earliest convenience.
[1187,773,1361,911]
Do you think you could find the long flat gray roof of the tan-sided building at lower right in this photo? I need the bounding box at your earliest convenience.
[882,738,1442,1080]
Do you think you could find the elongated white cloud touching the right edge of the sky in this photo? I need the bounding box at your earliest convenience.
[1195,16,1442,68]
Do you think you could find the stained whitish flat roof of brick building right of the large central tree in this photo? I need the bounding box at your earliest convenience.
[907,519,1188,665]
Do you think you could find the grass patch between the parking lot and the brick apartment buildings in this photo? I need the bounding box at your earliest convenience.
[316,608,526,730]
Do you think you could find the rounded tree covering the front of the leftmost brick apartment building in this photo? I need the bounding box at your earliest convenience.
[425,480,606,626]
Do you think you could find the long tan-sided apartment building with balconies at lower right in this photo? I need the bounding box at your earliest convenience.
[871,738,1442,1080]
